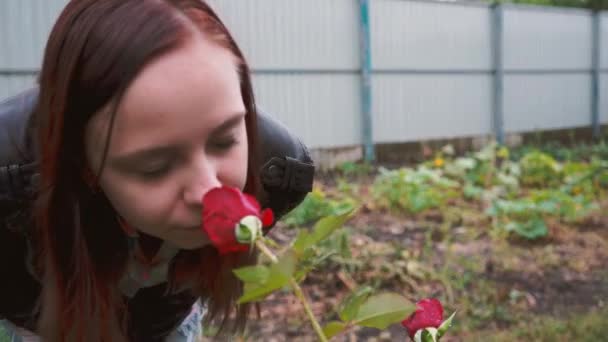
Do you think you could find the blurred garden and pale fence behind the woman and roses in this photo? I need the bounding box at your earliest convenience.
[0,0,608,341]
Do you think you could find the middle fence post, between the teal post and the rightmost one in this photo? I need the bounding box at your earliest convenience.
[492,2,505,144]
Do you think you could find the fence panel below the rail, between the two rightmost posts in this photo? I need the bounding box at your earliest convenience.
[504,74,591,132]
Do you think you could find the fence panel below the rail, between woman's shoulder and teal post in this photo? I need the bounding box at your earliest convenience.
[254,74,361,148]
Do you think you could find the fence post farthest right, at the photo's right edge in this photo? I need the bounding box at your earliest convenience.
[591,10,602,138]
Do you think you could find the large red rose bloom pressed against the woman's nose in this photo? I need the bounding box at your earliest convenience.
[202,186,274,254]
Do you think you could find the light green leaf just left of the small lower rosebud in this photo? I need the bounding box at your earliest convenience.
[354,293,415,329]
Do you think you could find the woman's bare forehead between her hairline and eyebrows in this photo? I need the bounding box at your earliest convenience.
[119,39,243,121]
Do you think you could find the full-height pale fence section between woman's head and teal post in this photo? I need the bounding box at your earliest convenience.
[210,0,361,147]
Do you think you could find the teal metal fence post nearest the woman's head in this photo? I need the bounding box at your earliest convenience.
[359,0,376,162]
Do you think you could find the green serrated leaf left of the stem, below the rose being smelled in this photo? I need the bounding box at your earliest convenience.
[238,253,297,304]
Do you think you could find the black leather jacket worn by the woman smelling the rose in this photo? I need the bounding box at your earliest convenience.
[0,88,314,341]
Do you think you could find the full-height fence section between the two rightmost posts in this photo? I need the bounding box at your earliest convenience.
[504,6,592,132]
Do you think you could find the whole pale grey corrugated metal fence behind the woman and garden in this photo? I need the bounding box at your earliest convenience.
[0,0,608,156]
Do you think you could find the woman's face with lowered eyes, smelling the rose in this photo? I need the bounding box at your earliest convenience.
[86,37,248,249]
